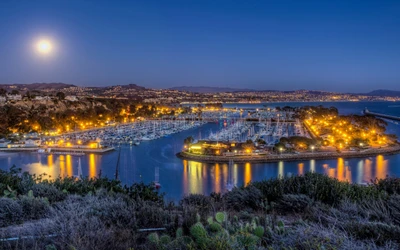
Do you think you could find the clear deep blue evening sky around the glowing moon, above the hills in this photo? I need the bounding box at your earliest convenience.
[0,0,400,92]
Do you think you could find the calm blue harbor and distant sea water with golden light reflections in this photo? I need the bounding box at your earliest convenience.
[0,102,400,201]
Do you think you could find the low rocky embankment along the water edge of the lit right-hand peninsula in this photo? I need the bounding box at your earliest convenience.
[176,145,400,163]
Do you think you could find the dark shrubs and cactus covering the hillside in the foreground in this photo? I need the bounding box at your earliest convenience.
[0,165,400,249]
